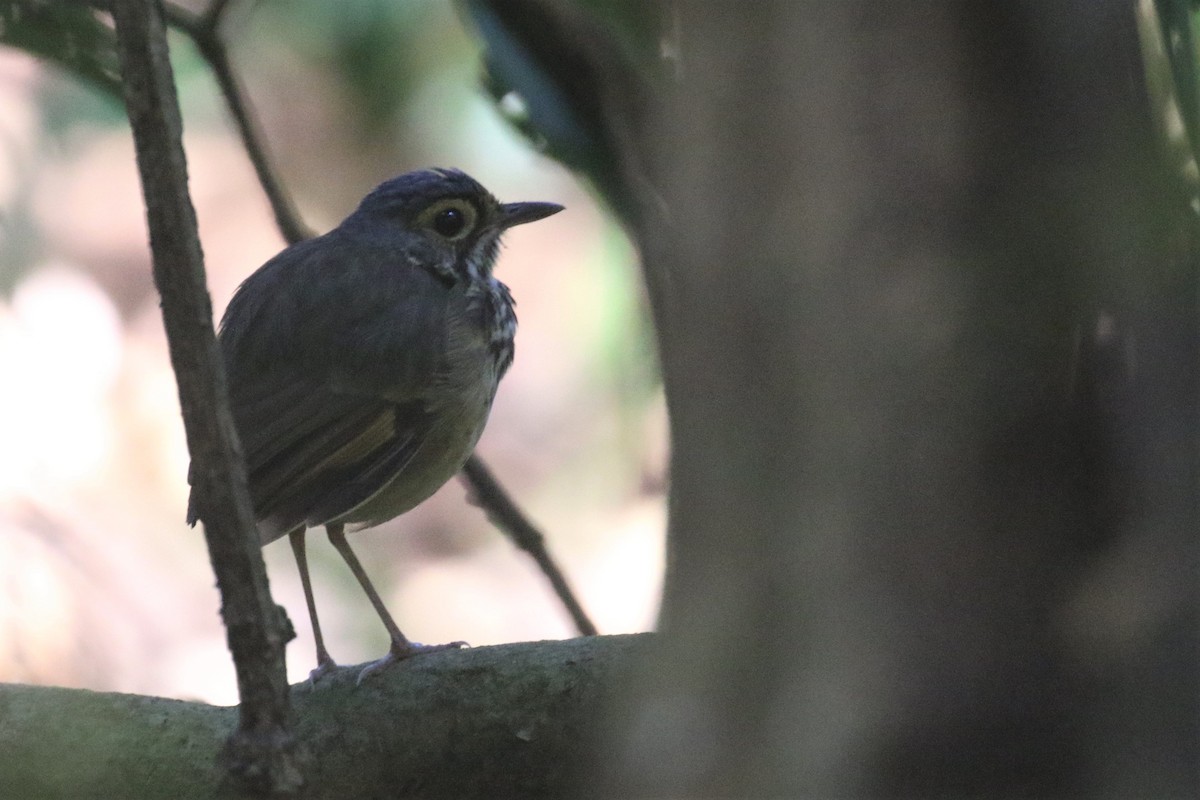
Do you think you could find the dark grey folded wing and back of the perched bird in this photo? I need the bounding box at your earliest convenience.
[187,231,449,541]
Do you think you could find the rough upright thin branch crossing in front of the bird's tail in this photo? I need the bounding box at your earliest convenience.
[112,0,300,796]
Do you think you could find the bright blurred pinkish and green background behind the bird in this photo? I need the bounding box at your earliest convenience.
[0,0,666,703]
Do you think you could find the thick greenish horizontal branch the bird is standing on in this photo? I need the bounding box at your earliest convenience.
[0,633,653,800]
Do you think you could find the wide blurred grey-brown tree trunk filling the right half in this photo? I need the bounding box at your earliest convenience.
[593,0,1200,798]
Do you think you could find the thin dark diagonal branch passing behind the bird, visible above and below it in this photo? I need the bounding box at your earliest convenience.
[166,0,596,636]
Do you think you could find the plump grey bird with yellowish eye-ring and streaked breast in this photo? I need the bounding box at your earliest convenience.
[187,169,563,681]
